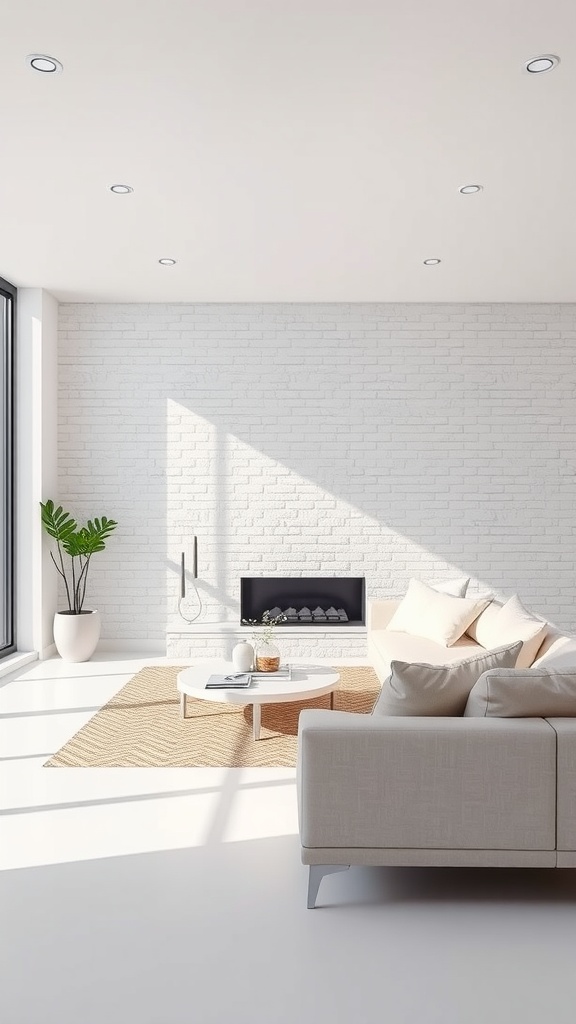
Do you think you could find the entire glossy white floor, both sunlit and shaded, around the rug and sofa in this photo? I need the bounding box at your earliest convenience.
[0,654,576,1024]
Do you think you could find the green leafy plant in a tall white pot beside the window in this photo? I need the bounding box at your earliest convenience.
[40,499,118,662]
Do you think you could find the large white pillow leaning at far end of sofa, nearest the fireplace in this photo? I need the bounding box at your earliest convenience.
[387,580,488,647]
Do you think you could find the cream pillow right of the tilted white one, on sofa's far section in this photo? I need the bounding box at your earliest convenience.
[467,594,548,669]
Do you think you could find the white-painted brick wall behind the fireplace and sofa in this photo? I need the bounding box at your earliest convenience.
[58,304,576,639]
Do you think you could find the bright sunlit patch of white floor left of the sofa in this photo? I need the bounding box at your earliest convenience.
[0,655,297,870]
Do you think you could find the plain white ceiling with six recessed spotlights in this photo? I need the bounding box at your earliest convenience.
[0,0,576,302]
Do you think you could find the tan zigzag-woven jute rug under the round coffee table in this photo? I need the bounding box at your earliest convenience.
[44,666,380,768]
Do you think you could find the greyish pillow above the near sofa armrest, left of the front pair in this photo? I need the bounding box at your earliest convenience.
[372,642,522,717]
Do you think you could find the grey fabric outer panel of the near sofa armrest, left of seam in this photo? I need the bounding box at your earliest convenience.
[297,710,556,862]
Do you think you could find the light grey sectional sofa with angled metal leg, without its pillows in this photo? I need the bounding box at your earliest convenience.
[297,601,576,907]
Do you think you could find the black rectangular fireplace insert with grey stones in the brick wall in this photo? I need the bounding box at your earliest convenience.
[240,577,366,628]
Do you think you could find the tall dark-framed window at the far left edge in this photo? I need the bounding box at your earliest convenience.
[0,278,16,657]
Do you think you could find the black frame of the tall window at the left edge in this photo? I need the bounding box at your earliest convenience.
[0,278,17,659]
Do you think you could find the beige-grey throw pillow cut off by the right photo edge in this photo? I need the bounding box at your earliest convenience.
[464,668,576,718]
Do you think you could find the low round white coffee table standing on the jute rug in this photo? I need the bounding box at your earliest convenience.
[176,663,340,739]
